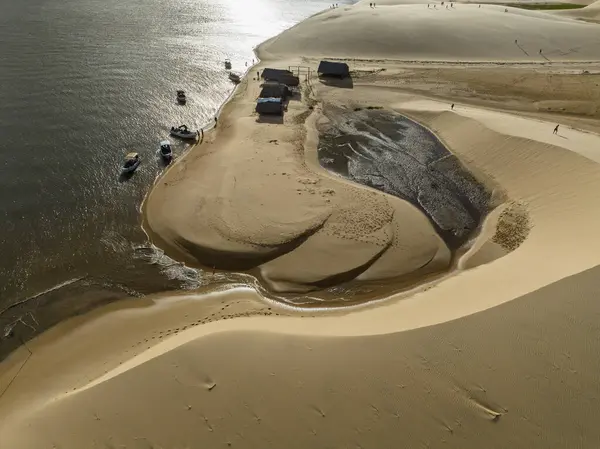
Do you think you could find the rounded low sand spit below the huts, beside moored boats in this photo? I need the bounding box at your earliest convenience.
[145,66,451,292]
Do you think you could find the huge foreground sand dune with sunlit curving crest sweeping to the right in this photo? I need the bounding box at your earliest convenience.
[0,96,600,449]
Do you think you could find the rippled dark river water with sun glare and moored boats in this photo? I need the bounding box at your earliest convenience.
[0,0,351,355]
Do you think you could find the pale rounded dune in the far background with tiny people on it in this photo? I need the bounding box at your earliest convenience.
[261,4,600,62]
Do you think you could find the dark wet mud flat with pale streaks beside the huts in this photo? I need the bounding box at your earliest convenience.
[318,107,491,249]
